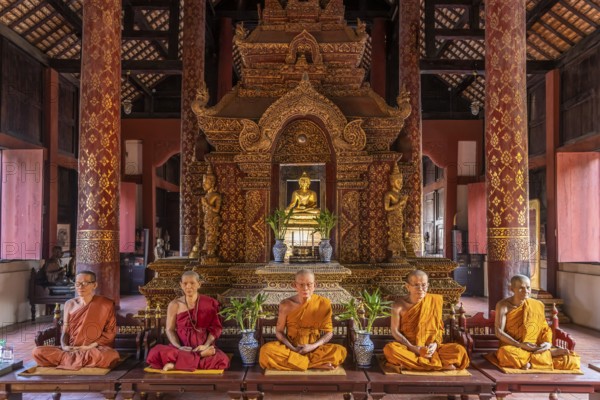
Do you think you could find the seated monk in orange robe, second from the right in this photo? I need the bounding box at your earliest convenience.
[383,270,469,371]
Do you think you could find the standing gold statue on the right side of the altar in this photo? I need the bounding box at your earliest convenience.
[383,163,408,261]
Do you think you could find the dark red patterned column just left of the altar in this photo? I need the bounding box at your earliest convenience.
[179,0,206,256]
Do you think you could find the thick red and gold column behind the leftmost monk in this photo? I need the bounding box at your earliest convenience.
[77,0,121,305]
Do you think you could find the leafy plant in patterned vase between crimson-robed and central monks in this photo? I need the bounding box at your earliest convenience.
[219,293,269,366]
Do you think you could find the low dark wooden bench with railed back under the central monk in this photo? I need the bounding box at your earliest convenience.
[244,318,369,400]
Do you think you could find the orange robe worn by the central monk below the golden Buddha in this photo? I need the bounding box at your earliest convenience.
[259,294,347,371]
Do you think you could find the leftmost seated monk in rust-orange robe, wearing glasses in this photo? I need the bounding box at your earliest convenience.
[33,271,119,370]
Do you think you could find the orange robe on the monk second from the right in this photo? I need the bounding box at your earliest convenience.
[383,294,469,371]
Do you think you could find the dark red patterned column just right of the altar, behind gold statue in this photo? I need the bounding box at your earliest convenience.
[398,0,423,255]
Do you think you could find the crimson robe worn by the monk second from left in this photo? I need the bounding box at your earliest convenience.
[146,295,229,371]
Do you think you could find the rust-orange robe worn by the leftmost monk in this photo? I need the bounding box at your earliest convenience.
[33,296,119,370]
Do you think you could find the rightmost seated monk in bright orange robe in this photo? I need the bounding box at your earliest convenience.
[495,275,580,370]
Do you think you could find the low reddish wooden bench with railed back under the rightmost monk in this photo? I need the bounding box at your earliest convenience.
[459,307,600,399]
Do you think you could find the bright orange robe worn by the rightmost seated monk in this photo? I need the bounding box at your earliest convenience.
[496,299,580,370]
